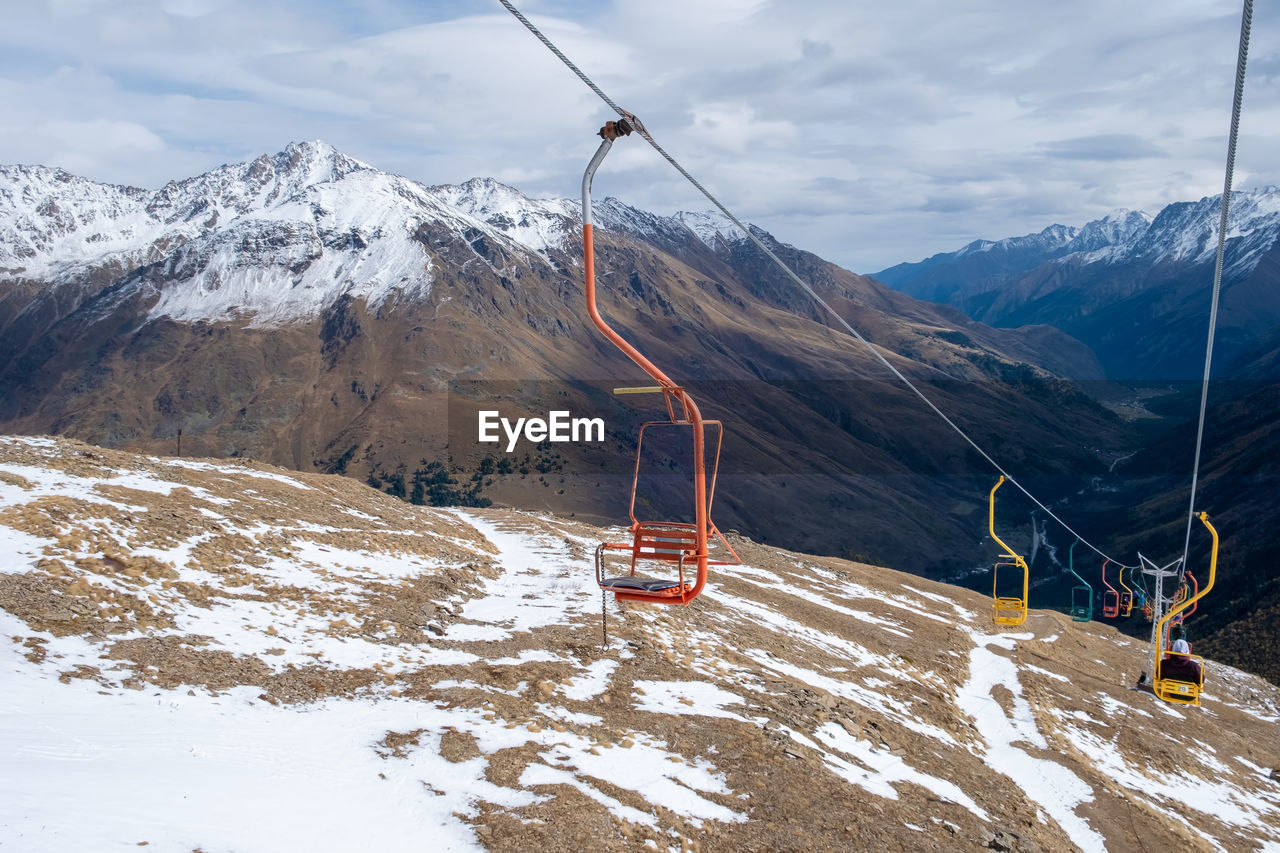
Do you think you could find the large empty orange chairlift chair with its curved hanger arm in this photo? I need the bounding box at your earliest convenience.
[582,117,739,605]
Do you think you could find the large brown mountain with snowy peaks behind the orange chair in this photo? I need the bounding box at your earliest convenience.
[0,142,1132,574]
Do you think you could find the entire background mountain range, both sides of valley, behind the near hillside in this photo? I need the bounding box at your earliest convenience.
[0,142,1280,678]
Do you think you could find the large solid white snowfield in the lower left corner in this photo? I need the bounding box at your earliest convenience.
[0,622,532,850]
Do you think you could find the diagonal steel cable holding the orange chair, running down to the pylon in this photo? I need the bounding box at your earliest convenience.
[498,0,1141,569]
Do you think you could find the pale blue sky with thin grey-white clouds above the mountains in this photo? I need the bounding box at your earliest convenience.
[0,0,1280,273]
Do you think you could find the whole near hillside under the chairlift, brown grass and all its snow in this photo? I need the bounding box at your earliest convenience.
[0,438,1280,852]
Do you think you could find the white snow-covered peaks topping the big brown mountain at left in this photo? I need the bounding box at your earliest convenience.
[0,140,768,325]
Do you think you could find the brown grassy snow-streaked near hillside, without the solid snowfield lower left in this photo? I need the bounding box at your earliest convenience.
[0,439,1280,850]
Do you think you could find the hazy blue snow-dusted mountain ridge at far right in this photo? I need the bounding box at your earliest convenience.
[874,194,1280,379]
